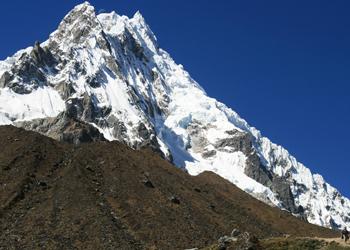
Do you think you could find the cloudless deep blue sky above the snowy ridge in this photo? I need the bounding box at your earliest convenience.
[0,0,350,197]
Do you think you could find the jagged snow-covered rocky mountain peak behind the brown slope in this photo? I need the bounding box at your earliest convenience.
[0,2,350,228]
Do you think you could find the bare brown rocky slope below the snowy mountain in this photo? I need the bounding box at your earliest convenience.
[0,126,338,249]
